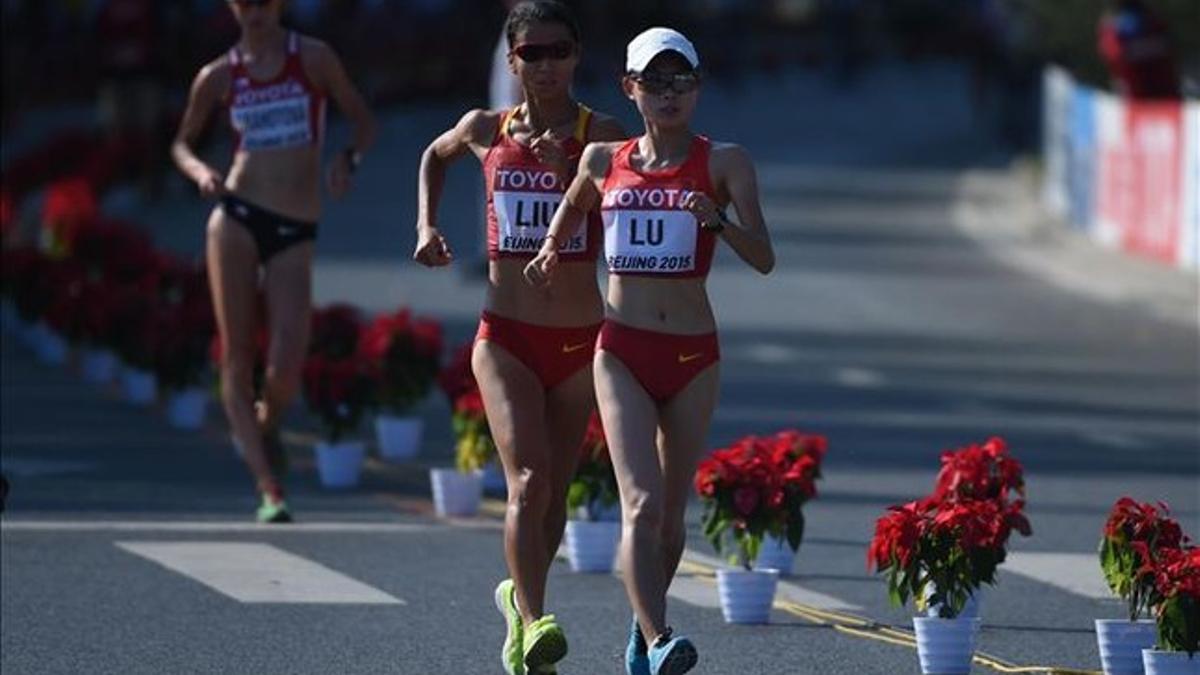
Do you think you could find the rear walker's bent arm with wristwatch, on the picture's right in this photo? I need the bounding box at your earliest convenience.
[305,38,377,198]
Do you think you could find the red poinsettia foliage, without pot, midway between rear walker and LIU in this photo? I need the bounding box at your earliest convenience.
[359,310,442,416]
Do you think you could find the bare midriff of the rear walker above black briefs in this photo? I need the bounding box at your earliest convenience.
[226,147,320,222]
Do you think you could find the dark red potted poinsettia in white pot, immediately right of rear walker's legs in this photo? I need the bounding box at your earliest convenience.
[304,305,374,488]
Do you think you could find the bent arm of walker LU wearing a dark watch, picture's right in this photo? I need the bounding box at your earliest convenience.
[684,144,775,274]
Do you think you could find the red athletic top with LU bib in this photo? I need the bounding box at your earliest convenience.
[600,136,716,277]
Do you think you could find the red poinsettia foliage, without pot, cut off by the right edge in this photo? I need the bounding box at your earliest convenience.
[1133,538,1200,658]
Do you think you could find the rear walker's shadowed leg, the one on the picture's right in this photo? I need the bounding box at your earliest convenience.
[258,241,313,431]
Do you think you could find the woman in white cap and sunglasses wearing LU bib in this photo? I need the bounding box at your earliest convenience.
[526,28,775,675]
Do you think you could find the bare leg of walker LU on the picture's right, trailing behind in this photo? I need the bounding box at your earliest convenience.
[659,364,720,591]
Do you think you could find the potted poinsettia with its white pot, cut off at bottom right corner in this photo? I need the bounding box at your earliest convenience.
[1133,540,1200,675]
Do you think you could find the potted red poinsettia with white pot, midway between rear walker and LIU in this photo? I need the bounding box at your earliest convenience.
[359,310,442,460]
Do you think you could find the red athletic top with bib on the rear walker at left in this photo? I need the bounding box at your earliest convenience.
[228,32,325,151]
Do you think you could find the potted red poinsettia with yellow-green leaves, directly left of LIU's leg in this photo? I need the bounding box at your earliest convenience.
[430,344,496,516]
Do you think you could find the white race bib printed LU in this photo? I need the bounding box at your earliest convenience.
[604,209,698,274]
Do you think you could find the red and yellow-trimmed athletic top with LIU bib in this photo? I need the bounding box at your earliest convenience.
[484,106,601,261]
